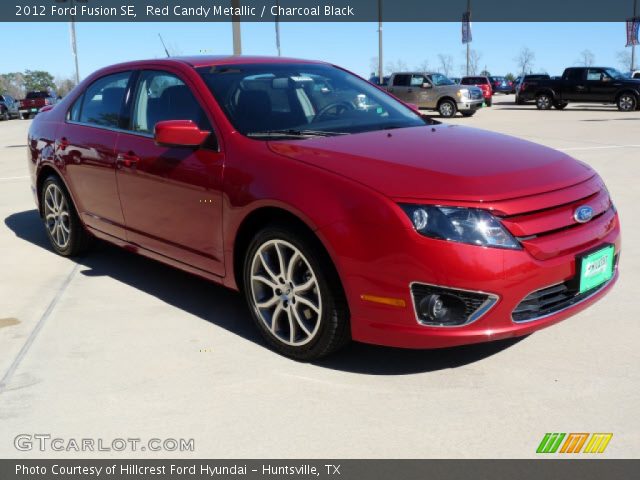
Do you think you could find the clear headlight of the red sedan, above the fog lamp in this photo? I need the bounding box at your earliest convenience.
[400,205,520,249]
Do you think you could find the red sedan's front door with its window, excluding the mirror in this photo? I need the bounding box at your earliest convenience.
[116,70,224,275]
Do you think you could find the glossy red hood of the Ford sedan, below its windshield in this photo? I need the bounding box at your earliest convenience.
[269,125,594,201]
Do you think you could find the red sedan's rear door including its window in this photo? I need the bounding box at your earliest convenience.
[56,71,132,239]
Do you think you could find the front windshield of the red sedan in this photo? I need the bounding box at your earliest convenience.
[197,63,426,138]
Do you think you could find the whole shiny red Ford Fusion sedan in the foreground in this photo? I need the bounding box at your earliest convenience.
[29,56,620,360]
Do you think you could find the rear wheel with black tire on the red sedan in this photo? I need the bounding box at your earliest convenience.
[40,175,93,257]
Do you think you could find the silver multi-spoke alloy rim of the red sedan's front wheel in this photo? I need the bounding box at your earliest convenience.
[250,240,322,347]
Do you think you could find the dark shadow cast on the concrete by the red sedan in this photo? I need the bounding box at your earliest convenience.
[4,209,521,375]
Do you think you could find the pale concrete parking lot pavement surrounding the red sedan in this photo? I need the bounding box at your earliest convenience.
[0,96,640,458]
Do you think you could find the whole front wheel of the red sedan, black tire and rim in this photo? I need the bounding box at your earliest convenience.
[243,224,351,361]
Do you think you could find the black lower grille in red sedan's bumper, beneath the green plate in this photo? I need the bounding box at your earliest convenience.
[511,255,618,323]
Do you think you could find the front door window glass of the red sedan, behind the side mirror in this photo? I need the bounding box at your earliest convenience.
[132,70,212,134]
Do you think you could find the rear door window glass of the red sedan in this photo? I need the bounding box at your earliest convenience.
[77,72,131,128]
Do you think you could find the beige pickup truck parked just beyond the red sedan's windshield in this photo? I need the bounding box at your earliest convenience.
[386,72,482,117]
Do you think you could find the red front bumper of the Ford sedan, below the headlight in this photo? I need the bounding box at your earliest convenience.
[324,214,620,348]
